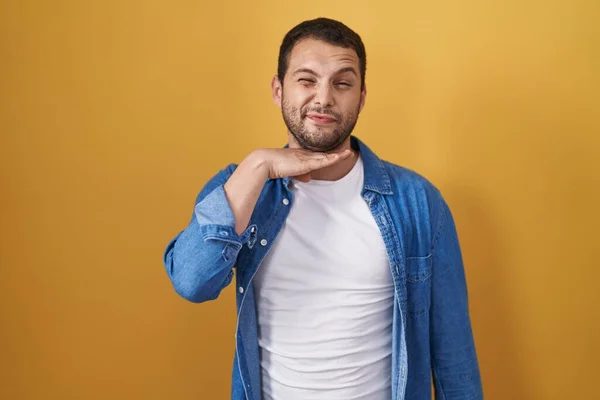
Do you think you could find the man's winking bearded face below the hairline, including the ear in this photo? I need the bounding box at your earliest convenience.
[272,39,366,152]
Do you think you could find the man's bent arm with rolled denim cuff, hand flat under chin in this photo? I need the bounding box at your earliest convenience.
[164,149,352,303]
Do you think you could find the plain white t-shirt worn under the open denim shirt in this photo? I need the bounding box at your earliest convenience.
[253,157,394,400]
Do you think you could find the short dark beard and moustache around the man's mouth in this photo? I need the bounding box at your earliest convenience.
[281,99,359,153]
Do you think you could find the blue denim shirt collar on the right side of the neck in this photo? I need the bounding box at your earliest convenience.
[282,136,394,195]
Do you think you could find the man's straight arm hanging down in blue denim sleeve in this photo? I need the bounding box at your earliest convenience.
[430,199,483,400]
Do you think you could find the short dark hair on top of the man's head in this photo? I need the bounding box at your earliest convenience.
[277,18,367,89]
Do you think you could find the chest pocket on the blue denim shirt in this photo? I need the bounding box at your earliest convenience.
[406,254,433,316]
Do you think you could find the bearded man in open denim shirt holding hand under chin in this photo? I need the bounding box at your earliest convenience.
[165,18,483,400]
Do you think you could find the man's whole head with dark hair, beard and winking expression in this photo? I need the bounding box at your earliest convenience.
[272,18,367,151]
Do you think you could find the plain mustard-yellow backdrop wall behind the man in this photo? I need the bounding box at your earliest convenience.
[0,0,600,400]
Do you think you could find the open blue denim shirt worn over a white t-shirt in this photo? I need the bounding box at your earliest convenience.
[164,137,483,400]
